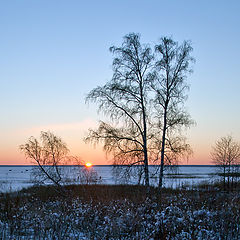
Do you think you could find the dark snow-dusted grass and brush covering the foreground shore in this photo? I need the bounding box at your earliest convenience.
[0,185,240,240]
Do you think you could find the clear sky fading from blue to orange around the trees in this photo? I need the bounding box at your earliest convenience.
[0,0,240,165]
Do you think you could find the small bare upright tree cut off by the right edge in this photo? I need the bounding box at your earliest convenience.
[211,136,240,190]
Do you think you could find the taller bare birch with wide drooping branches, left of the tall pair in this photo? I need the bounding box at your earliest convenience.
[87,33,153,186]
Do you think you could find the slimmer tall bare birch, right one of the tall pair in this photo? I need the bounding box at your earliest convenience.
[151,37,194,188]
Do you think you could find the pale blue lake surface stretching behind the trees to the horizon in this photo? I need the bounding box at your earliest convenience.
[0,165,216,192]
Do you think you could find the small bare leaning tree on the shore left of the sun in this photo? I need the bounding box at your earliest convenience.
[19,132,69,187]
